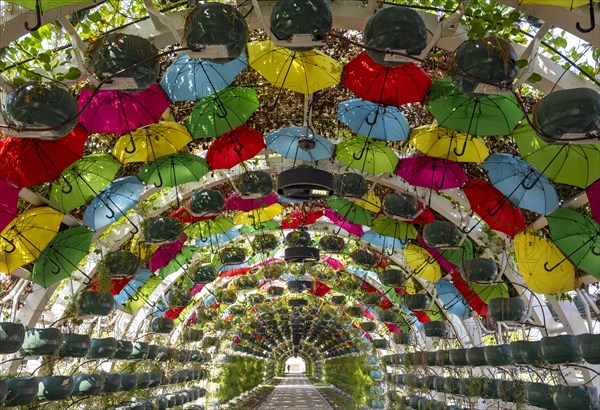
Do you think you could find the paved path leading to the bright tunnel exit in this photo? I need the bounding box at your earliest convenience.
[260,376,333,410]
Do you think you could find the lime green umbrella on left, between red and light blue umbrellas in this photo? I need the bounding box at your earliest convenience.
[50,154,121,212]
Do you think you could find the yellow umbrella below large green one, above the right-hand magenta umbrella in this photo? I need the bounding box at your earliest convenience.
[408,125,490,163]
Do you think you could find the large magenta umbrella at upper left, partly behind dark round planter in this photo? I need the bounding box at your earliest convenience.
[78,84,171,135]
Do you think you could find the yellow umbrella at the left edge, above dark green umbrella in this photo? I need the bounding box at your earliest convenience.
[0,207,63,274]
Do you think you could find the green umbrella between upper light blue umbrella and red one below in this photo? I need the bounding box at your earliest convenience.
[187,87,258,138]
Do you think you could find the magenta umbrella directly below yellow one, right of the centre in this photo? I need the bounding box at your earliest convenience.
[396,156,469,190]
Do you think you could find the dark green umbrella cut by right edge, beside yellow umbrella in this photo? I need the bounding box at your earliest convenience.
[545,208,600,279]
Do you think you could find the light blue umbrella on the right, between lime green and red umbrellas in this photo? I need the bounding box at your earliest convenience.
[483,153,558,215]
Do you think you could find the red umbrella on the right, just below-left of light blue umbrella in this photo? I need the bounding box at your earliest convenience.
[463,179,525,237]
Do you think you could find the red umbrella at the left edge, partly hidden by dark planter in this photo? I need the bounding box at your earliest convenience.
[0,126,89,188]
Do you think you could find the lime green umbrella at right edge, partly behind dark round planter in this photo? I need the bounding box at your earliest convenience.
[513,121,600,188]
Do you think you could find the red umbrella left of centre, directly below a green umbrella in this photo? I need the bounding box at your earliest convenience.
[206,125,265,169]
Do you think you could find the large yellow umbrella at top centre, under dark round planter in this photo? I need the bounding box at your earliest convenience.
[248,41,343,94]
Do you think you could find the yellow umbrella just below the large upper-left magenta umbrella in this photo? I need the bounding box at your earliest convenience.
[113,121,192,164]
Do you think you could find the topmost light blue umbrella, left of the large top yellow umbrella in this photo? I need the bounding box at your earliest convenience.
[160,52,248,102]
